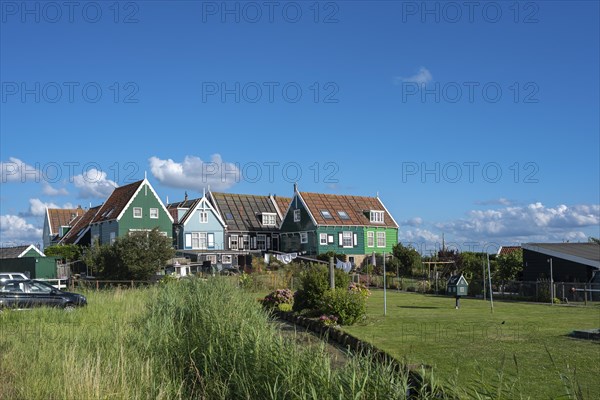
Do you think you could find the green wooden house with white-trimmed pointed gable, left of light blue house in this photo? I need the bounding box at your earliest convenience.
[86,179,173,244]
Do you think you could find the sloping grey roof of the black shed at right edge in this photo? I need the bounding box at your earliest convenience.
[522,243,600,268]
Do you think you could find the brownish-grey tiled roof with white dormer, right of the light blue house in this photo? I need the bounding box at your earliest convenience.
[208,192,281,232]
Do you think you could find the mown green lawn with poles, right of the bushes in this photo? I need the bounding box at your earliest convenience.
[344,291,600,399]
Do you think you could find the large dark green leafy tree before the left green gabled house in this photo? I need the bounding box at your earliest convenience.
[92,229,175,280]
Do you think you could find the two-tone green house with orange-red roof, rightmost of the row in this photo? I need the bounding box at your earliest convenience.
[280,186,398,264]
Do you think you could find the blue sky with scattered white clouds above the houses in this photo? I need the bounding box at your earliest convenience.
[0,0,600,253]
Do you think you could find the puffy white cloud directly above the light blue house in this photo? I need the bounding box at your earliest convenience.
[148,154,242,192]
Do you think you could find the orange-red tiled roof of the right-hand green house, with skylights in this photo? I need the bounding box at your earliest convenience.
[298,192,398,228]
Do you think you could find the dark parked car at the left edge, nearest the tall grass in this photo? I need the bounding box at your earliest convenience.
[0,279,87,312]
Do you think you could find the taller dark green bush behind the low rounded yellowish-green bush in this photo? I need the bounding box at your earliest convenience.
[294,264,350,311]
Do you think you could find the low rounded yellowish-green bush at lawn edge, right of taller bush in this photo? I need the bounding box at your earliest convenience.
[322,288,367,325]
